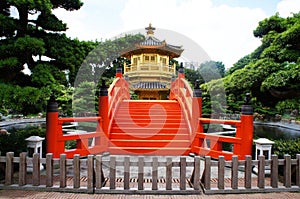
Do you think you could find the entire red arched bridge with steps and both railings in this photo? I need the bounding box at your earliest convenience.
[46,68,253,160]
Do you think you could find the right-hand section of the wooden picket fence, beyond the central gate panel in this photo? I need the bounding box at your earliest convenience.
[201,155,300,194]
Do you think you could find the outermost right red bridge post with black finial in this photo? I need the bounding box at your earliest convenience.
[236,93,253,160]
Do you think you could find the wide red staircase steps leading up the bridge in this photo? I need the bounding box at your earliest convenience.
[109,100,190,155]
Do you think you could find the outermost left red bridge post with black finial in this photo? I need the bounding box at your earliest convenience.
[46,95,64,158]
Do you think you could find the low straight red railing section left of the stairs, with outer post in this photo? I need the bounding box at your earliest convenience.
[46,100,104,158]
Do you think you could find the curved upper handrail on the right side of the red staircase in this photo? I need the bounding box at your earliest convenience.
[170,78,193,135]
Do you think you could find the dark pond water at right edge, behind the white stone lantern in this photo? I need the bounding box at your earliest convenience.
[254,124,300,140]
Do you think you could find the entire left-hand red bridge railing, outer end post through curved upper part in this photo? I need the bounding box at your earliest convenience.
[46,68,130,158]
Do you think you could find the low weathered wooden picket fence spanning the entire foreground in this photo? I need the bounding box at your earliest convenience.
[0,152,300,194]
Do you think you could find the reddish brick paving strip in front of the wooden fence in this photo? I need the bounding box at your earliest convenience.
[0,190,300,199]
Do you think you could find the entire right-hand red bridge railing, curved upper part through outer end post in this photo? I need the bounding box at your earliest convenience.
[170,67,253,160]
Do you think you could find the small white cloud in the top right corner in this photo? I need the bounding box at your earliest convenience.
[277,0,300,17]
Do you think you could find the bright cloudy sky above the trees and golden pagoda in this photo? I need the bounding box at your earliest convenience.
[54,0,300,68]
